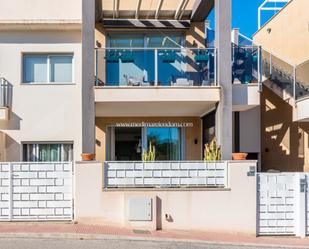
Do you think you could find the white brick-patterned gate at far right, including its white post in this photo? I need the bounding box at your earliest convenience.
[257,173,309,237]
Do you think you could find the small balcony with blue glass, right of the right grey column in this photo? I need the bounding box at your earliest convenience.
[232,45,262,111]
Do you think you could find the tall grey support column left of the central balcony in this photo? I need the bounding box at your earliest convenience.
[81,0,95,153]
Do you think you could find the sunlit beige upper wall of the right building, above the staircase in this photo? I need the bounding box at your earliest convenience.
[253,0,309,65]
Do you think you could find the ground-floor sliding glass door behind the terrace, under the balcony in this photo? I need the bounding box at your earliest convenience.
[106,127,184,161]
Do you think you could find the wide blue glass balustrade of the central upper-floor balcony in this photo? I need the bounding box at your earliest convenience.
[96,48,216,86]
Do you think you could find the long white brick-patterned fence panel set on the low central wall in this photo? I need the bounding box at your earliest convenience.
[104,161,228,188]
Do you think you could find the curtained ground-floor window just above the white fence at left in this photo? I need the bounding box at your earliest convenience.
[23,143,73,162]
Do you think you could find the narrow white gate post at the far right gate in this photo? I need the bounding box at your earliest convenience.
[295,173,307,238]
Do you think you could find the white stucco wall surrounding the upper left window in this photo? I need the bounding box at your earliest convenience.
[0,30,81,161]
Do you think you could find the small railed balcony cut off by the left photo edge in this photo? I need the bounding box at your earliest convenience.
[0,78,12,121]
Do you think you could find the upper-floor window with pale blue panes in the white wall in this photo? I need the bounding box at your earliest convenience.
[23,54,73,83]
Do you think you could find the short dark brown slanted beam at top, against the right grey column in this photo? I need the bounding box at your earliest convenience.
[191,0,215,22]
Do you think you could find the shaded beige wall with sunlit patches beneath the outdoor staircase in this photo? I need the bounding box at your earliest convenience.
[261,87,309,172]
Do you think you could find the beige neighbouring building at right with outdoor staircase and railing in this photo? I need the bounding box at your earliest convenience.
[253,0,309,171]
